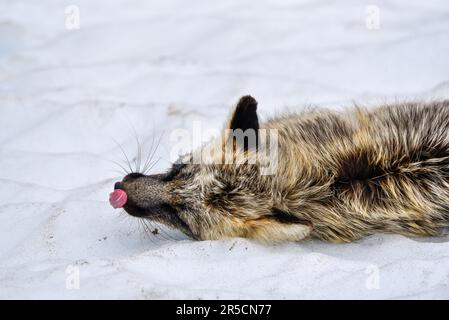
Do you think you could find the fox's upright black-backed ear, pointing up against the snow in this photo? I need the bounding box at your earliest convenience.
[226,95,259,150]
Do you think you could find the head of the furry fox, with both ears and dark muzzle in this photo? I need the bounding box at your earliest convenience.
[115,96,310,242]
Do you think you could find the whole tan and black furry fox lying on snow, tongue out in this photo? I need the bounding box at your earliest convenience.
[111,95,449,243]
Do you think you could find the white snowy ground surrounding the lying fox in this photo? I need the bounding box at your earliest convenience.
[0,0,449,299]
